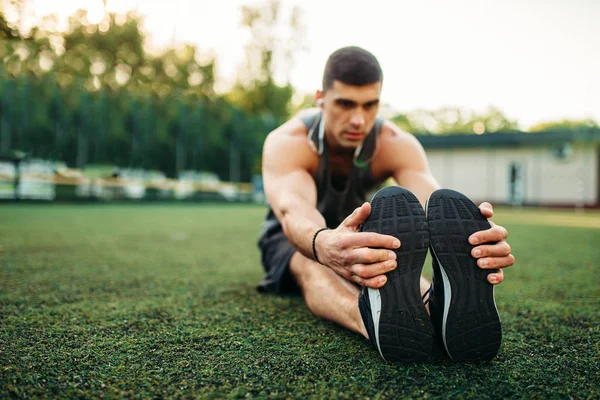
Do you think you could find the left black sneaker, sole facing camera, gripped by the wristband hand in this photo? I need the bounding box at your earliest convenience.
[358,186,432,362]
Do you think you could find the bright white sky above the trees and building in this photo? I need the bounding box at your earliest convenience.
[33,0,600,129]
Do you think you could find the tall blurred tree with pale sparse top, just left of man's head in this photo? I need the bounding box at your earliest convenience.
[227,0,305,180]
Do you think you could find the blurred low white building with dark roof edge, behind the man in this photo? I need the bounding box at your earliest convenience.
[416,130,600,207]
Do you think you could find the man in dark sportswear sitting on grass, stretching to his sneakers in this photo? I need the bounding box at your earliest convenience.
[259,47,514,362]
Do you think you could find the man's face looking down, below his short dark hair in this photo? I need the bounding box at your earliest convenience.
[317,81,381,149]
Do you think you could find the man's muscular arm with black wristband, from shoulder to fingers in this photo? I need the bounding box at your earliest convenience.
[263,120,400,288]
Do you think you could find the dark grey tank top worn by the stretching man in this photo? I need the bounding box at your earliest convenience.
[261,109,383,237]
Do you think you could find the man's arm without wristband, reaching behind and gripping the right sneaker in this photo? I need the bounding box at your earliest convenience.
[382,125,515,284]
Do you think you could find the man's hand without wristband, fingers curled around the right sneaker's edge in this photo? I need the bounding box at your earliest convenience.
[469,202,515,285]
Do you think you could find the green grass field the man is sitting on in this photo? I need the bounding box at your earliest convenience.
[0,204,600,399]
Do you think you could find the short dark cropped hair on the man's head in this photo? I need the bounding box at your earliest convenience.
[323,46,383,92]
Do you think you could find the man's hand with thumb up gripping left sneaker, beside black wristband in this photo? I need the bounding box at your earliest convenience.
[315,203,400,288]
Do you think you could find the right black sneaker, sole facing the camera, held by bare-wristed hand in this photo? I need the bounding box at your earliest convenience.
[425,189,502,361]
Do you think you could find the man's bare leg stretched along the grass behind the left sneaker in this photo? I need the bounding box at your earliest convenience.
[290,252,368,337]
